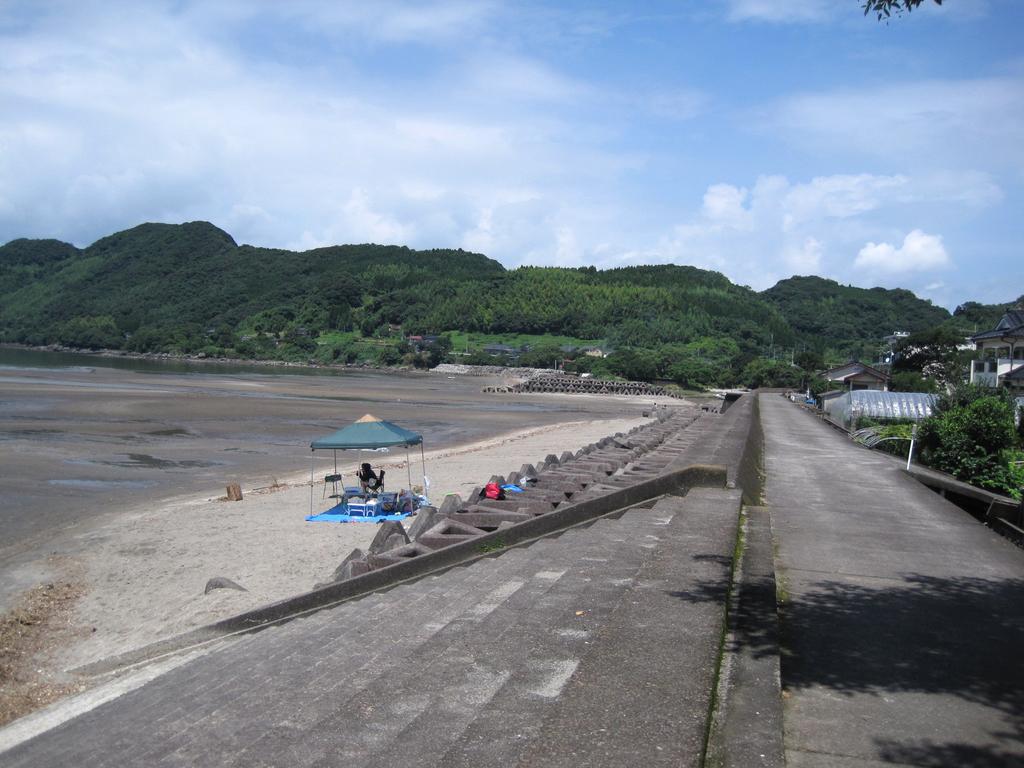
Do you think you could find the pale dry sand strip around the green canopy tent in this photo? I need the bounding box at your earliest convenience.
[37,418,646,670]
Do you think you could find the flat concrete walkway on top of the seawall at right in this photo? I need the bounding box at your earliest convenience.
[760,394,1024,768]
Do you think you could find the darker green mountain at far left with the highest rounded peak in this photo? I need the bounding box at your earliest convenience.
[0,222,505,351]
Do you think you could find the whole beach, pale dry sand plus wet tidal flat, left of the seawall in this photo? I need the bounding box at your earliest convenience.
[0,352,685,715]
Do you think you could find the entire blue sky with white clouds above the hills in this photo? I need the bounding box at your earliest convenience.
[0,0,1024,309]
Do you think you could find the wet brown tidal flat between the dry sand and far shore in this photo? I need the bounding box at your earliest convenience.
[0,357,649,565]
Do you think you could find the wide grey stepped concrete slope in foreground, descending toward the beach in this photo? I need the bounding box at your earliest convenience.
[2,492,735,767]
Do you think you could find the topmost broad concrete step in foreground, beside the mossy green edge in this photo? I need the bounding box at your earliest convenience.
[521,492,739,767]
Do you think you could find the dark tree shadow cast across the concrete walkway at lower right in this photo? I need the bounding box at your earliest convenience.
[670,573,1024,768]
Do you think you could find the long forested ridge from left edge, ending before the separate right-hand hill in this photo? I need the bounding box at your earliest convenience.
[0,222,792,352]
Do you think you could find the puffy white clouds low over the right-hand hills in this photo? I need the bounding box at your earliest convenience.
[624,173,966,290]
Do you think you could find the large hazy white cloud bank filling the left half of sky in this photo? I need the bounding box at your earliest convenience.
[0,3,622,252]
